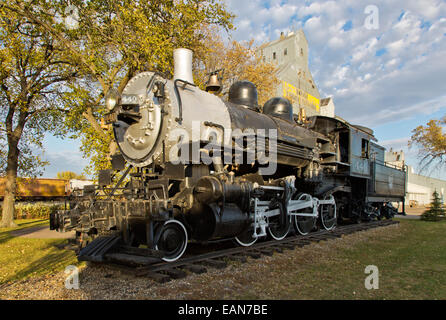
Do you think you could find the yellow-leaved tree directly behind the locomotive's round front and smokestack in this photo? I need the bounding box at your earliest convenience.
[9,0,233,173]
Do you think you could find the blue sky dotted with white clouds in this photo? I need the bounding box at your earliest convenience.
[40,0,446,178]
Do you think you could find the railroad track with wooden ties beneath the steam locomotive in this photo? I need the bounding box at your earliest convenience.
[96,220,399,283]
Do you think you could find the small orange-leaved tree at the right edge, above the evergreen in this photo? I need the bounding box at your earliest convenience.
[409,116,446,167]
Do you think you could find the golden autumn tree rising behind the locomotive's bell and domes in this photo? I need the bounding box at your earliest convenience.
[194,27,279,105]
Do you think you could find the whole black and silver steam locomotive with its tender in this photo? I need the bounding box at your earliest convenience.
[51,49,405,262]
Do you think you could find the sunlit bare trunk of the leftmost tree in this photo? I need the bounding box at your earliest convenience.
[0,142,19,228]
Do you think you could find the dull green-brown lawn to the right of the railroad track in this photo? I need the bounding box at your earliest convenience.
[233,220,446,299]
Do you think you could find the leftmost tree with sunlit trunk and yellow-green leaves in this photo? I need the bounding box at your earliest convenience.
[0,0,76,227]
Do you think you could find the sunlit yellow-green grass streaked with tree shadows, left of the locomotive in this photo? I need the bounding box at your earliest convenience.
[0,219,77,285]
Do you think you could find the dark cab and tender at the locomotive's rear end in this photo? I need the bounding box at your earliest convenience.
[308,116,406,222]
